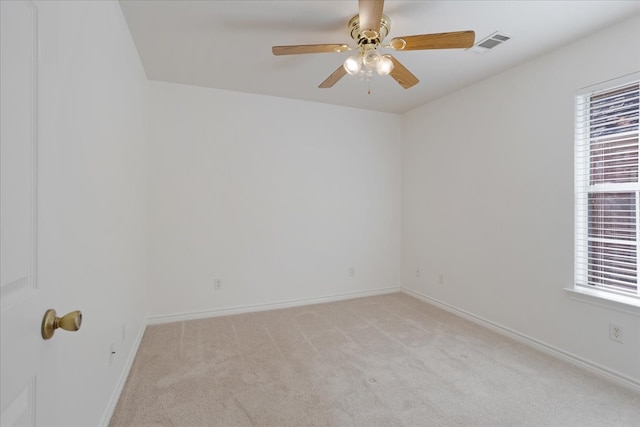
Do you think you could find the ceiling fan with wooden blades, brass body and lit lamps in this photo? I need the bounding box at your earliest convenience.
[271,0,475,89]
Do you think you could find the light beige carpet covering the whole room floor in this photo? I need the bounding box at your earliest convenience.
[110,293,640,427]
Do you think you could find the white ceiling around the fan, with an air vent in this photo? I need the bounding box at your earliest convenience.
[120,0,640,113]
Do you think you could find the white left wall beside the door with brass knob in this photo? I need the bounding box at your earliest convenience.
[36,1,147,427]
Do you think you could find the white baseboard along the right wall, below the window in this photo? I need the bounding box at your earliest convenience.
[400,287,640,392]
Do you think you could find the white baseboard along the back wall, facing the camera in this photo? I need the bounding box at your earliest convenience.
[147,287,400,325]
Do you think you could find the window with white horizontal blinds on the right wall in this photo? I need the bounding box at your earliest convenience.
[575,73,640,298]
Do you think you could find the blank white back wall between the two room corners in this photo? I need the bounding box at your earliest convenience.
[149,82,401,318]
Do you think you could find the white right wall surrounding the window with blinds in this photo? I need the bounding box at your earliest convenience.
[402,17,640,385]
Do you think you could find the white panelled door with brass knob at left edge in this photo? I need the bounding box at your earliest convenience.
[0,0,57,427]
